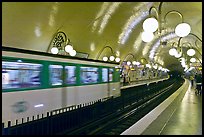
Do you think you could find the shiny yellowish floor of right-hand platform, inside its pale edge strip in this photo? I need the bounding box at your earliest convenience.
[142,81,202,135]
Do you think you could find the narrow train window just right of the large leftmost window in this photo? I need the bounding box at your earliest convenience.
[49,65,63,86]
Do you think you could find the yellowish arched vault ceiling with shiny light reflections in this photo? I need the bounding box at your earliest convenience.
[2,2,202,73]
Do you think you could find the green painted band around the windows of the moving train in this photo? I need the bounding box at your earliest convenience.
[2,56,120,92]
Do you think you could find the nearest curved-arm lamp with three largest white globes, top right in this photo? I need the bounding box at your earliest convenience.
[142,2,191,43]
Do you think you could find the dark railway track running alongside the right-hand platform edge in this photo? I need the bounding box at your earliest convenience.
[67,78,182,135]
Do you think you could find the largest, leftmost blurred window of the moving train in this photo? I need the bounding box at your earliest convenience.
[2,61,42,89]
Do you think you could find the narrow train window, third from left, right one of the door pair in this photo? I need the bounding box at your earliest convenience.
[65,66,76,84]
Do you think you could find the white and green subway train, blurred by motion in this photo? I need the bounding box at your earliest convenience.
[2,47,121,122]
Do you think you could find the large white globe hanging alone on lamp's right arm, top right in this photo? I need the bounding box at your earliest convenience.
[175,23,191,37]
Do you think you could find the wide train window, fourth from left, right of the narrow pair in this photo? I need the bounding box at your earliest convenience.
[81,67,98,84]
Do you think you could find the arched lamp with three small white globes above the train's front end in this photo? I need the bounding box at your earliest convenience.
[96,46,120,62]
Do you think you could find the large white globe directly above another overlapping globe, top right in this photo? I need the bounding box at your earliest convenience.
[143,18,159,32]
